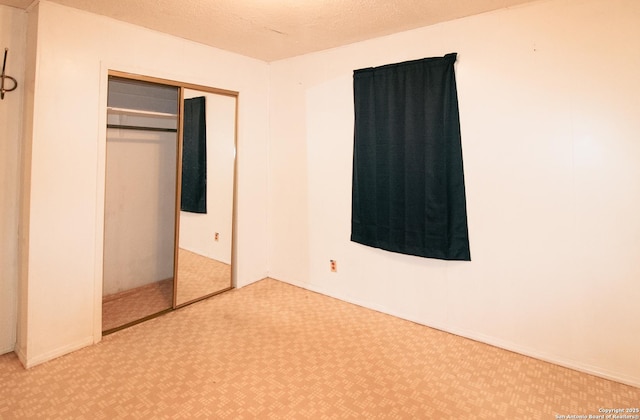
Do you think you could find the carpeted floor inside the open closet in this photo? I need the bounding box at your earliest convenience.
[102,279,173,331]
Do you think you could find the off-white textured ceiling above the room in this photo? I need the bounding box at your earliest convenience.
[0,0,537,61]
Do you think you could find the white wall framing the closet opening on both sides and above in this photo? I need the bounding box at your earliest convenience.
[16,1,268,366]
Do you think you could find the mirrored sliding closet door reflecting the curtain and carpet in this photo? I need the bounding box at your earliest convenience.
[176,88,237,306]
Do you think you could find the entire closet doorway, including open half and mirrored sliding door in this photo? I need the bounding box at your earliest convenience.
[102,70,238,335]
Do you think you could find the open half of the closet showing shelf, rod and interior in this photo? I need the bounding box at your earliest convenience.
[102,76,179,332]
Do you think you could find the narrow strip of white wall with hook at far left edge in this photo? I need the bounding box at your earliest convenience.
[0,6,27,354]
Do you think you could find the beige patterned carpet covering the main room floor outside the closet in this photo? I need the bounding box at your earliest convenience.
[0,279,640,420]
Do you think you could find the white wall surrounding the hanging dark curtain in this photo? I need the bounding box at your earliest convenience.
[269,0,640,386]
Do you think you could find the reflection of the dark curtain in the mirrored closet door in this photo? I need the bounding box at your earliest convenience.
[180,96,207,213]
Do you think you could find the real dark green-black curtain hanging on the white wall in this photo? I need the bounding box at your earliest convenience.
[351,53,471,261]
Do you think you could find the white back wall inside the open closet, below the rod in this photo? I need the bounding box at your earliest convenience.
[102,126,178,296]
